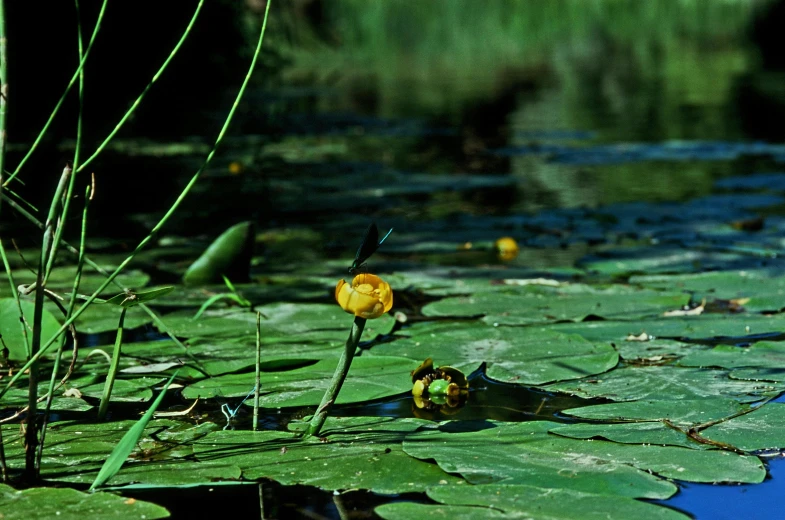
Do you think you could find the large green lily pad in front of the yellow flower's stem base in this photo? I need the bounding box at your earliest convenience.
[194,416,463,494]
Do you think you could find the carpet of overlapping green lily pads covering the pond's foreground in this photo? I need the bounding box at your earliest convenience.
[0,173,785,519]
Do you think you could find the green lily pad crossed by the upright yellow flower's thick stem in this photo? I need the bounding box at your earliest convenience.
[183,356,418,408]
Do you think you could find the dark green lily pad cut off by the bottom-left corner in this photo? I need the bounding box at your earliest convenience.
[0,484,169,520]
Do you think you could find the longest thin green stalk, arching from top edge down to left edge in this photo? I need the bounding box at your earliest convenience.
[0,0,271,397]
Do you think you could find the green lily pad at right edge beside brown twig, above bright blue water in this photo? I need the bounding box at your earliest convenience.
[701,403,785,451]
